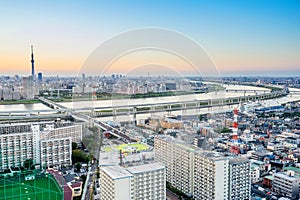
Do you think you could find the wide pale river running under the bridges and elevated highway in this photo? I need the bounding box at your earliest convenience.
[0,85,300,121]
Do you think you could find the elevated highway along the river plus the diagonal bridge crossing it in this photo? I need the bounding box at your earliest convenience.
[0,91,287,142]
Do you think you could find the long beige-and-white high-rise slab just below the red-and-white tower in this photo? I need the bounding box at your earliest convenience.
[154,136,251,200]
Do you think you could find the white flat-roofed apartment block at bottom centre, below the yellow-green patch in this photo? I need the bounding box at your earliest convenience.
[100,163,166,200]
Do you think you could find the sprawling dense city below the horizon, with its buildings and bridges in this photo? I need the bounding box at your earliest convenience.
[0,73,300,200]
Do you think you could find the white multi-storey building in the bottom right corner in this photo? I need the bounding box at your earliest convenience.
[272,171,300,199]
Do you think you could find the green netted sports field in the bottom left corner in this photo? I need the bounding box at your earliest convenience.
[0,175,63,200]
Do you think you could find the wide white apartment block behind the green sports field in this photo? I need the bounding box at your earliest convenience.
[0,122,82,170]
